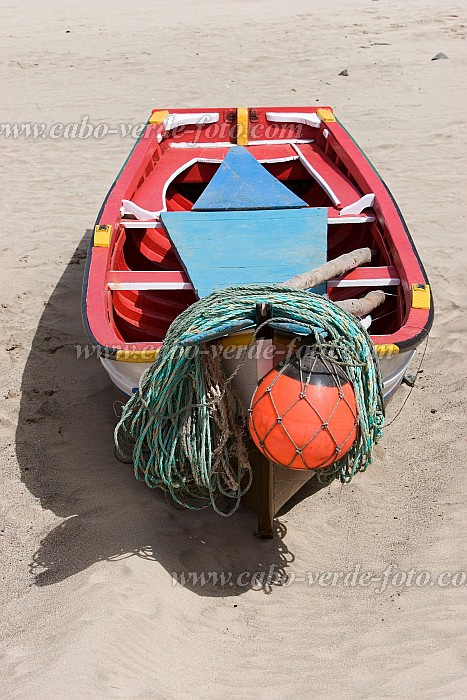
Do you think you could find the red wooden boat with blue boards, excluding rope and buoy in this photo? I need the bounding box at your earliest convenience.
[83,106,433,532]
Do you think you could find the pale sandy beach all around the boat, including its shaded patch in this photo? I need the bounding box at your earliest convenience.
[0,0,467,699]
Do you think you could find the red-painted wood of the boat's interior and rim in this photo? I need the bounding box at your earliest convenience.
[86,108,428,349]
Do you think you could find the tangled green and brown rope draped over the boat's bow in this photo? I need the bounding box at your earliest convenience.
[115,285,384,515]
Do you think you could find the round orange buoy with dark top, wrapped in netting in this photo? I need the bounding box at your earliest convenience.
[248,346,358,469]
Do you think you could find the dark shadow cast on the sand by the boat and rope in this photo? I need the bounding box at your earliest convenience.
[16,231,304,596]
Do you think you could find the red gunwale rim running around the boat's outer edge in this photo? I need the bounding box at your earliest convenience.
[82,107,434,361]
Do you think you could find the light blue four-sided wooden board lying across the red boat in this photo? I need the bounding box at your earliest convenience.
[161,207,328,298]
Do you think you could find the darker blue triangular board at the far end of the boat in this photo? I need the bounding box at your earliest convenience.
[193,146,308,211]
